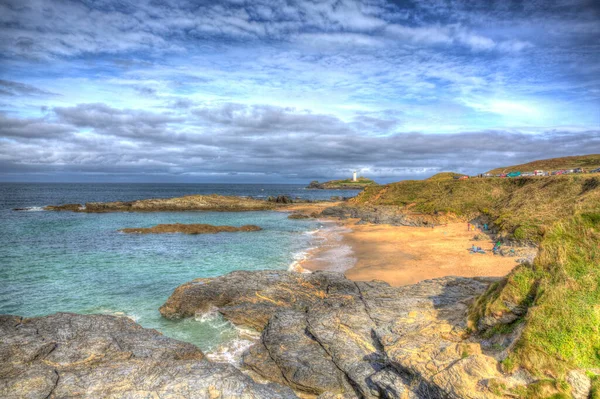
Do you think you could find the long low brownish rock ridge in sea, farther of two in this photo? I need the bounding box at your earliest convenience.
[44,194,276,213]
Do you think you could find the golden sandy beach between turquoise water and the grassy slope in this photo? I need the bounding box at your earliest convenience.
[300,221,517,286]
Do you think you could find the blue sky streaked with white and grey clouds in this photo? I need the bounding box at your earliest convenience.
[0,0,600,183]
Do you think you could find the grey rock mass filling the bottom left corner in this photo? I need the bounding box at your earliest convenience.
[0,313,296,399]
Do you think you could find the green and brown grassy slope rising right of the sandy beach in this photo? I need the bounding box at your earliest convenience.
[352,175,600,384]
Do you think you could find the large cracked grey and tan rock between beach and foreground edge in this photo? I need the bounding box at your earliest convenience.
[160,271,503,399]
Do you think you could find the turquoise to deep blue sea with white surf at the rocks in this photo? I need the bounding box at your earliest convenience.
[0,183,358,362]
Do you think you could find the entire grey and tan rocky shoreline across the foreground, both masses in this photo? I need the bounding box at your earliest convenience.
[0,271,536,399]
